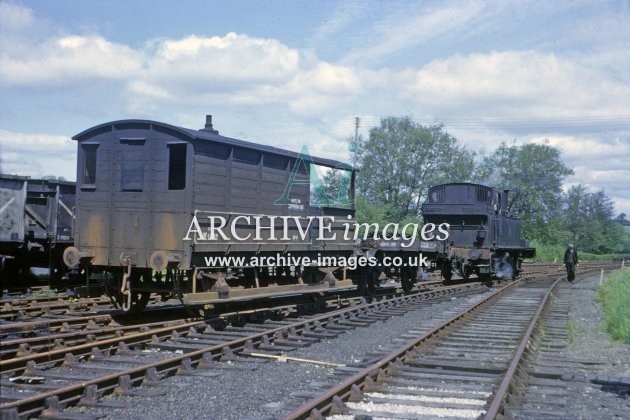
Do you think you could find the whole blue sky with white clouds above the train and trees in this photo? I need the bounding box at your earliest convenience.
[0,0,630,216]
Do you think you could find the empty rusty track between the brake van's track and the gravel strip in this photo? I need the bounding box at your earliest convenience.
[0,283,485,416]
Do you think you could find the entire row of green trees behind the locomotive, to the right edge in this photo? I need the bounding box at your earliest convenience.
[349,116,630,254]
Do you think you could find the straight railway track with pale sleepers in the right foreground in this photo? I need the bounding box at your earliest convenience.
[287,266,616,419]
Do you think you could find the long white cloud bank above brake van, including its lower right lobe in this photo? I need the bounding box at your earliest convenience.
[127,33,370,116]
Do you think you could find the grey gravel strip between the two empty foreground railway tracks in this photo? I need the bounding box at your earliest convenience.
[65,292,488,419]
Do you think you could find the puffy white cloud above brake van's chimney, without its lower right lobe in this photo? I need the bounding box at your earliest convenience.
[127,33,314,113]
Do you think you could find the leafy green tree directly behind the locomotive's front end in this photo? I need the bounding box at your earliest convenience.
[481,143,573,242]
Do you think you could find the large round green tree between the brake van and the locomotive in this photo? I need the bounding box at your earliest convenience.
[355,117,474,222]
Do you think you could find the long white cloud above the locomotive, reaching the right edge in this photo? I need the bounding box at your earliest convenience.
[398,51,630,118]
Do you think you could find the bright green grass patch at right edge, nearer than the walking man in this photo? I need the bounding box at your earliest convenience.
[597,268,630,344]
